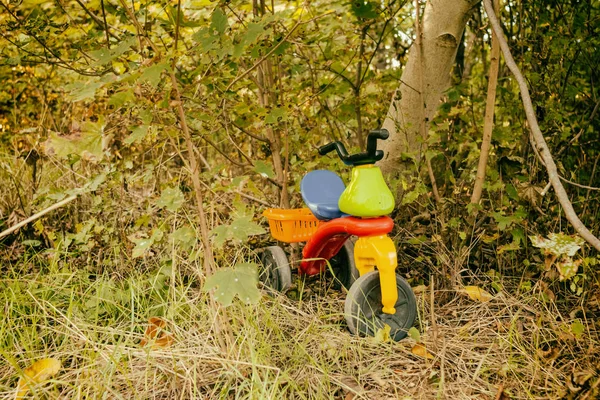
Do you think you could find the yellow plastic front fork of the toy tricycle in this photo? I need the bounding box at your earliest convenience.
[354,235,398,314]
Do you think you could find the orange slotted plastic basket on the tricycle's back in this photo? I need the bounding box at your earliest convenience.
[263,208,321,243]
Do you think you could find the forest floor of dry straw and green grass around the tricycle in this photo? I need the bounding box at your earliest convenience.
[0,238,600,400]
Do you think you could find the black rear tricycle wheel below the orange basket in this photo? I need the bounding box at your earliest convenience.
[258,246,292,292]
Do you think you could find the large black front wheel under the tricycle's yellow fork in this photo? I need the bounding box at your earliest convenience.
[344,271,417,342]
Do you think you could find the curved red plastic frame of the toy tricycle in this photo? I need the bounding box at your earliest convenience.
[298,216,394,275]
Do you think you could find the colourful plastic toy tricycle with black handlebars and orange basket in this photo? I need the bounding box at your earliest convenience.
[260,129,417,341]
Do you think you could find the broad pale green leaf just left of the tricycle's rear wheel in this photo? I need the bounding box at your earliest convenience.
[202,263,260,307]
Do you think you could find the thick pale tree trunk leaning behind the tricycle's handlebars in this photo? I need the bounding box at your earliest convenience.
[378,0,479,173]
